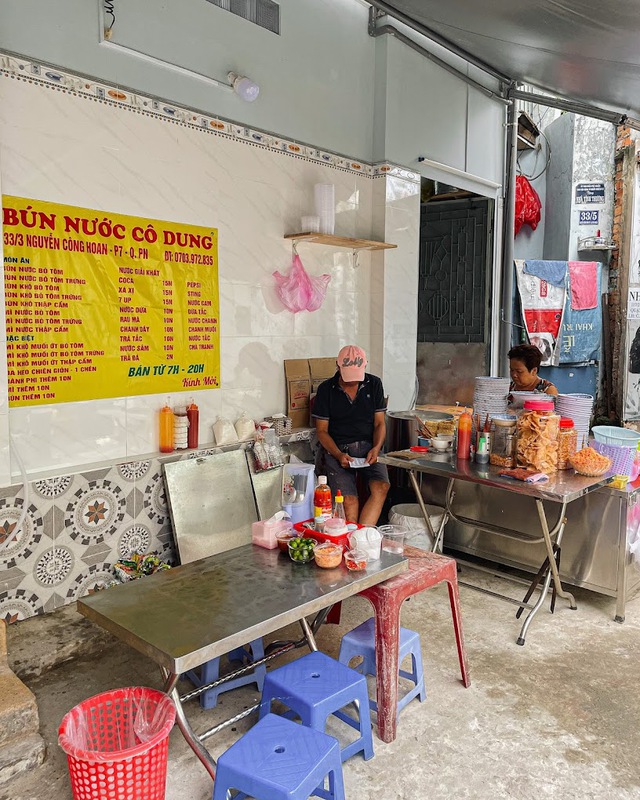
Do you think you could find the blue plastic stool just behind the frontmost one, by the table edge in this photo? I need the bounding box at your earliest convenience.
[260,652,373,761]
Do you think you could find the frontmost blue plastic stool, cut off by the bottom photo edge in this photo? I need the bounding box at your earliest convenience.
[213,714,345,800]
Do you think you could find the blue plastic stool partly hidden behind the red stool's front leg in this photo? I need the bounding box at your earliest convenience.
[338,617,427,714]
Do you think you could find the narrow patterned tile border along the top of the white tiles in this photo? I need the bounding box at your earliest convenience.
[0,53,420,183]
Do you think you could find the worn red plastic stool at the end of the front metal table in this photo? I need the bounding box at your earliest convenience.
[360,545,471,742]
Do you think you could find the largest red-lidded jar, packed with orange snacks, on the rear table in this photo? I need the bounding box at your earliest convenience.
[516,400,560,475]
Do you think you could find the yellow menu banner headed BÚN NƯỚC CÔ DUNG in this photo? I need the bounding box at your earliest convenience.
[3,196,220,407]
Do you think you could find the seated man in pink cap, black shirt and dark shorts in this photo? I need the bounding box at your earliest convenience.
[313,345,389,525]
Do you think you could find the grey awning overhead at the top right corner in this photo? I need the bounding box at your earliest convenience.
[372,0,640,117]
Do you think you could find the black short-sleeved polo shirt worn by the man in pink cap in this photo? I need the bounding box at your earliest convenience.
[312,372,386,446]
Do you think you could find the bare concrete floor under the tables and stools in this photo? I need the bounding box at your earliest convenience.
[0,568,640,800]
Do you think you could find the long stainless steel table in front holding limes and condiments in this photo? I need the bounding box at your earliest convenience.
[78,545,408,778]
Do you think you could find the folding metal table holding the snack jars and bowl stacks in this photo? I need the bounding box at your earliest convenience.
[379,453,609,645]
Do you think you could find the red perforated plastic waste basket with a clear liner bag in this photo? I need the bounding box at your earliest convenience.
[58,686,176,800]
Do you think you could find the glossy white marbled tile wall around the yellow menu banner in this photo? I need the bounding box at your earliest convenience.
[0,75,419,478]
